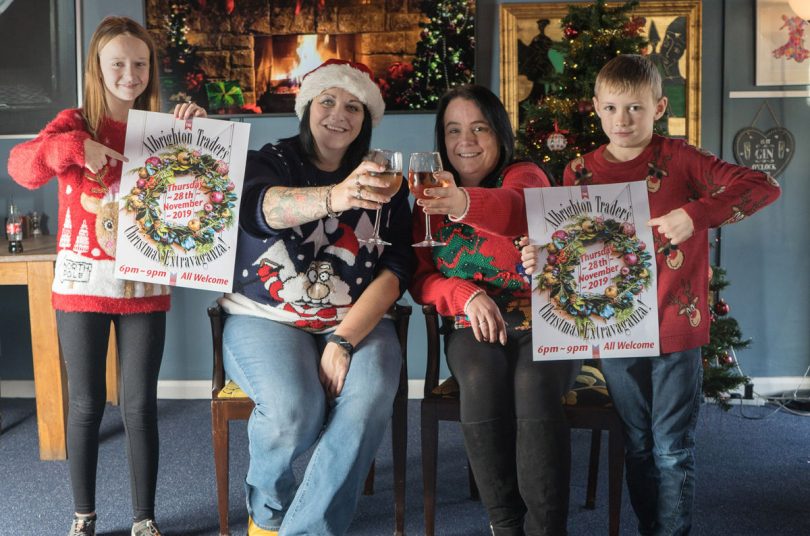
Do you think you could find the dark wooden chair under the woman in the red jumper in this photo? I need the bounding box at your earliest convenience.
[421,305,624,536]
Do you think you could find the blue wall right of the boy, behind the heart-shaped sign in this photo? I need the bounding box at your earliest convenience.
[716,0,810,376]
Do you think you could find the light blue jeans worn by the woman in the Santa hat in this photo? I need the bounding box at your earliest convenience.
[223,315,402,536]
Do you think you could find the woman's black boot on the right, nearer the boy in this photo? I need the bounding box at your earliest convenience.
[516,419,571,536]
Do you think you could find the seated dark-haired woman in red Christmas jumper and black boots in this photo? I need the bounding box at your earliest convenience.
[410,86,580,536]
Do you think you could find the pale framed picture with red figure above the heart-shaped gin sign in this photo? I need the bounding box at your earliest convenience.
[756,0,810,86]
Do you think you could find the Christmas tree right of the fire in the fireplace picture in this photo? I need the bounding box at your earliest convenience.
[403,0,475,109]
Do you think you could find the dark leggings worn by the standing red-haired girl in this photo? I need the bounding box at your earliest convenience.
[56,311,166,521]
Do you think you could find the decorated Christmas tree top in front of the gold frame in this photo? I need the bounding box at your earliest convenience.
[517,0,648,182]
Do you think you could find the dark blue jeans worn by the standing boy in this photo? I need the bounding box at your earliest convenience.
[601,348,703,536]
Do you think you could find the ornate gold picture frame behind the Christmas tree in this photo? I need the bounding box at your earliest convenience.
[500,0,702,146]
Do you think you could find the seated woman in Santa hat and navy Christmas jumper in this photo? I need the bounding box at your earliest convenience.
[220,60,414,535]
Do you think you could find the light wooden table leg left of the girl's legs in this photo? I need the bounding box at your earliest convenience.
[28,261,67,460]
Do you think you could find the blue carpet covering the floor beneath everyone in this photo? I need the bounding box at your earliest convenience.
[0,399,810,536]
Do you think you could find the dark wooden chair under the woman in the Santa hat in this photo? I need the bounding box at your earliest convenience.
[208,304,411,536]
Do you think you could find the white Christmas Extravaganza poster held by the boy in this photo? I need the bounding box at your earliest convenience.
[524,181,660,361]
